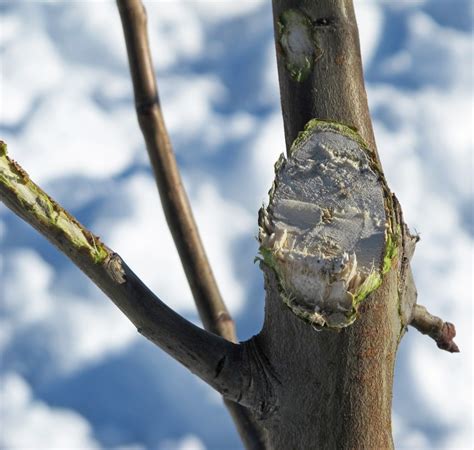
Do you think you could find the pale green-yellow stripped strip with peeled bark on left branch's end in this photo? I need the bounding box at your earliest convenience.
[0,141,109,264]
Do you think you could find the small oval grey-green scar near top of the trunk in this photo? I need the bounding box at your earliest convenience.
[277,9,322,82]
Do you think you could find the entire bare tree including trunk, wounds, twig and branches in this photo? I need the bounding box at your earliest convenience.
[0,0,458,450]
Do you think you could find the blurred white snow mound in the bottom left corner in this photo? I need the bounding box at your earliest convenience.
[0,373,100,450]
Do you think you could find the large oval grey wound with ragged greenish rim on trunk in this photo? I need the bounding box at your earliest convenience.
[259,121,393,328]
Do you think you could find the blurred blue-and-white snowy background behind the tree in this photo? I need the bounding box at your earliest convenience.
[0,0,474,450]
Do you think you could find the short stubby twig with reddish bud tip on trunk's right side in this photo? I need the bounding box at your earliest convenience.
[410,305,459,353]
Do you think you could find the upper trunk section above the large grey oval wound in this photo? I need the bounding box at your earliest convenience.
[272,0,376,158]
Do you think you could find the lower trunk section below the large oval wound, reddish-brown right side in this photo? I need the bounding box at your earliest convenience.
[254,271,401,449]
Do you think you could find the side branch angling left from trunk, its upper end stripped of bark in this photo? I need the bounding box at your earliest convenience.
[0,141,245,400]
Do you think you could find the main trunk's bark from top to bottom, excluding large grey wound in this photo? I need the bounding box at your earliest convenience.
[243,0,412,449]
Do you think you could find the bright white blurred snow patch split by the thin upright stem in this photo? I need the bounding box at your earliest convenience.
[95,175,253,312]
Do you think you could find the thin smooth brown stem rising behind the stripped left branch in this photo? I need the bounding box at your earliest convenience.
[117,0,236,342]
